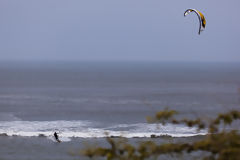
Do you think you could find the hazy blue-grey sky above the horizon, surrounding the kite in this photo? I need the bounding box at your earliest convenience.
[0,0,240,62]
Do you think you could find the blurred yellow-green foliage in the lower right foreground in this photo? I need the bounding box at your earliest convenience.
[82,109,240,160]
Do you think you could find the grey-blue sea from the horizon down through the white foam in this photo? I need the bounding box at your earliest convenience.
[0,62,240,141]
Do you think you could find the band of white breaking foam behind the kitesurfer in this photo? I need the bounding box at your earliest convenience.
[0,121,207,141]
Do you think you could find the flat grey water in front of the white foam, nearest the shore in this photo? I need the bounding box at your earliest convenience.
[0,136,204,160]
